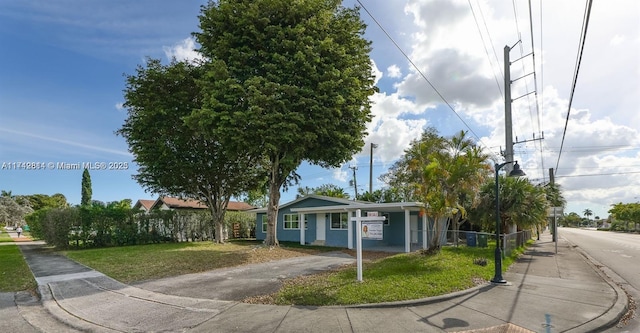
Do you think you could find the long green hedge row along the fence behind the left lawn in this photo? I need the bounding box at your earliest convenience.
[25,206,255,249]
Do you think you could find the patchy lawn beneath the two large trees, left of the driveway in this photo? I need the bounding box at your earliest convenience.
[63,241,335,283]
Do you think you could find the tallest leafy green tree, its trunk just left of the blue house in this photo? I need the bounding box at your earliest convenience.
[189,0,375,245]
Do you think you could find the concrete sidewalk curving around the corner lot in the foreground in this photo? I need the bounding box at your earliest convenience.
[0,234,627,332]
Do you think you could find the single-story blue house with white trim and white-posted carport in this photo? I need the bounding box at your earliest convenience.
[252,195,432,252]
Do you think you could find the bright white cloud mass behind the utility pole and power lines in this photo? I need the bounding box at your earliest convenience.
[352,0,640,217]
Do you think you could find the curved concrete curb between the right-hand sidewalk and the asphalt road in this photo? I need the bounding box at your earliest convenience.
[562,237,629,333]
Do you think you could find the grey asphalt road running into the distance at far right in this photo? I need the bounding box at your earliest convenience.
[558,228,640,332]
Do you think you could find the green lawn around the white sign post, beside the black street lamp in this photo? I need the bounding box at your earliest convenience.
[268,243,522,306]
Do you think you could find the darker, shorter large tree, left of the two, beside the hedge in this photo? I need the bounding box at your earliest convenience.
[118,59,259,242]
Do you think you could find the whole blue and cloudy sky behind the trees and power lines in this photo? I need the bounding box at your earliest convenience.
[0,0,640,218]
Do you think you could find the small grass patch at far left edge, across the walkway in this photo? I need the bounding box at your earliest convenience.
[0,244,37,292]
